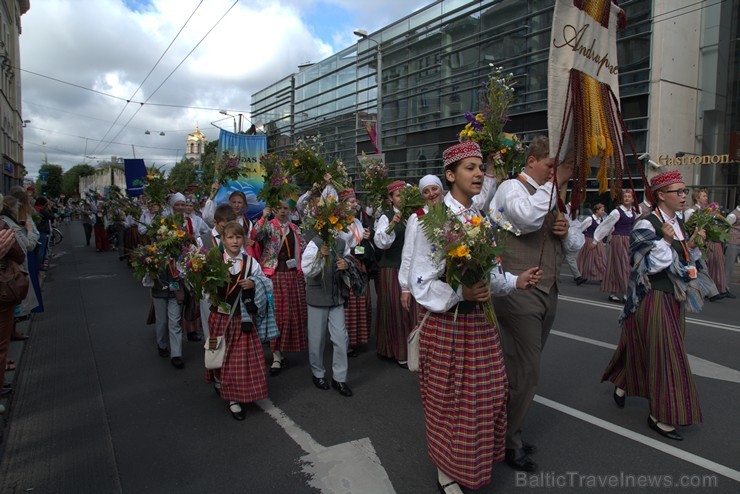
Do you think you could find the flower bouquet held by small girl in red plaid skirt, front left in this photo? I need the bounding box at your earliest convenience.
[178,244,231,305]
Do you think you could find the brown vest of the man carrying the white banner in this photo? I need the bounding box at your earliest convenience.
[501,179,565,293]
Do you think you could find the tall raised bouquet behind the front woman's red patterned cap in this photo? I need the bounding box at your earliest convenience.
[458,67,525,180]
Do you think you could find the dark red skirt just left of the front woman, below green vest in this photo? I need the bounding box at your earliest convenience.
[375,268,411,362]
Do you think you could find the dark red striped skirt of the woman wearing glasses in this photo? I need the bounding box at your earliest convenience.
[601,290,702,425]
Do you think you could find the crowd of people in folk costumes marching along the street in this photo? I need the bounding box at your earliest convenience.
[0,136,740,493]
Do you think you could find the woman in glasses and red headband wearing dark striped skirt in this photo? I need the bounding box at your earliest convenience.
[602,171,706,441]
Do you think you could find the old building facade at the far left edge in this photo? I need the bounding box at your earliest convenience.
[0,0,31,193]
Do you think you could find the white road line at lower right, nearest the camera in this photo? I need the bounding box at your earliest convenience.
[534,395,740,482]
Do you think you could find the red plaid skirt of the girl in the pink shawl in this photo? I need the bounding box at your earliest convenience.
[270,270,308,352]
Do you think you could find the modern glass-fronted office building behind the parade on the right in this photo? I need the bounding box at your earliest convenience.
[251,0,740,206]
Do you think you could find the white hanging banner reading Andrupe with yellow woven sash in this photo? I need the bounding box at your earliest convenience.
[547,0,644,212]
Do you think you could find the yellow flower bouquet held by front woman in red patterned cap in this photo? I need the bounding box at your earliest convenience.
[419,204,504,325]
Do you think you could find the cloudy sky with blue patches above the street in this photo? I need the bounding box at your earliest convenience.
[19,0,432,179]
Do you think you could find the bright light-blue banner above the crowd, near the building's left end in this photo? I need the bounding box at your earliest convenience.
[214,129,267,218]
